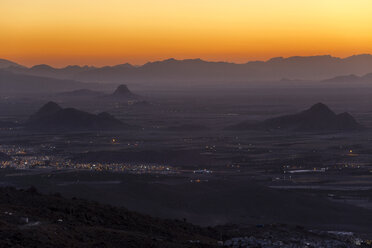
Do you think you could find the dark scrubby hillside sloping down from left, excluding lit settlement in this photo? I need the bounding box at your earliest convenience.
[0,188,218,247]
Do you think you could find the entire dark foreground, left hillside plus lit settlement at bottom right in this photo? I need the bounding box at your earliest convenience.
[0,187,370,247]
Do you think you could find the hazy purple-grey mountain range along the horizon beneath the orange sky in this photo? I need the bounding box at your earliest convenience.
[0,54,372,83]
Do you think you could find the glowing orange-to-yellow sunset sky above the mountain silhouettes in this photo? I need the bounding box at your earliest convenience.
[0,0,372,66]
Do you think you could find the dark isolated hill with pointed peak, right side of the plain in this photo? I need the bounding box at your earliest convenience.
[230,103,361,131]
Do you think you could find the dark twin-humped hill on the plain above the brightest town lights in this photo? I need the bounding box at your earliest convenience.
[26,102,130,131]
